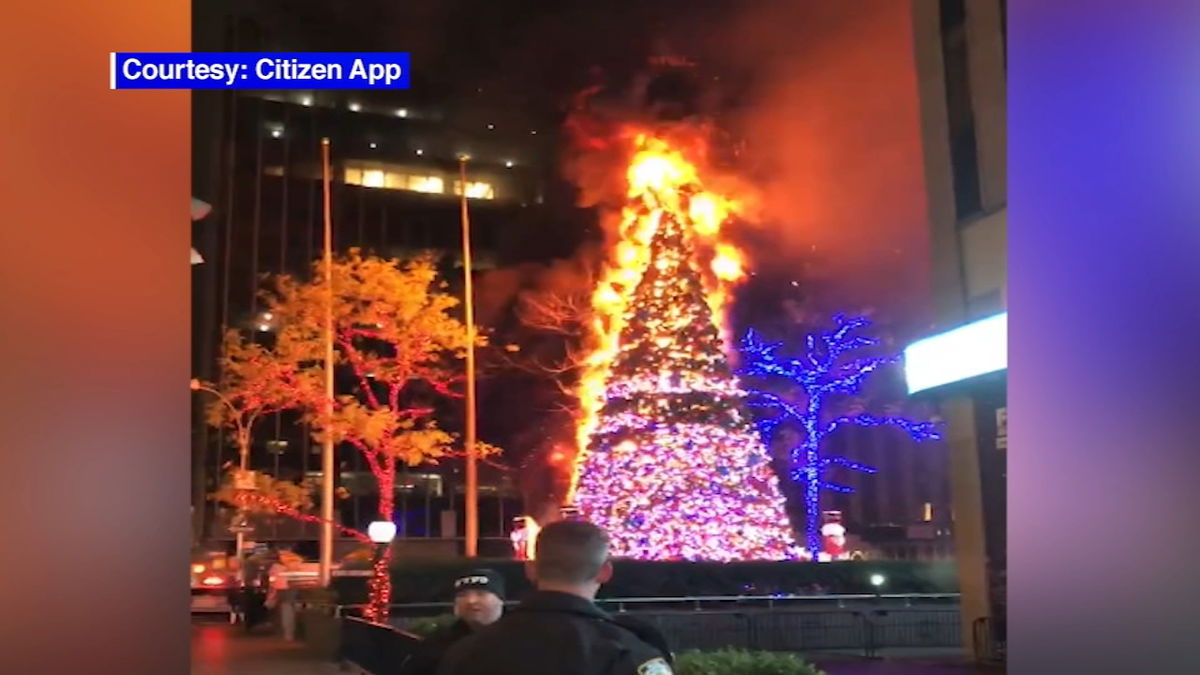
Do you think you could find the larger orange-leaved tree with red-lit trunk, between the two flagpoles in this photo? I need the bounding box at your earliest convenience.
[268,250,496,621]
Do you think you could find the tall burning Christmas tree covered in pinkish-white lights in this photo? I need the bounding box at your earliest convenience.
[572,137,798,561]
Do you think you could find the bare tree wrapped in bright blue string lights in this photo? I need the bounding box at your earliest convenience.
[740,315,941,560]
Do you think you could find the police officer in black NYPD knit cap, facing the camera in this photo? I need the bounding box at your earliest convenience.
[400,569,504,675]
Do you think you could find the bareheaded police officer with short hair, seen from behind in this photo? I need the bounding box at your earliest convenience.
[438,521,673,675]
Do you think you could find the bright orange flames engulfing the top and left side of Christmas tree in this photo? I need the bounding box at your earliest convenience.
[568,132,746,500]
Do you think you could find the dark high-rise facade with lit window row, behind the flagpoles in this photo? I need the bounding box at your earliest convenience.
[193,2,580,554]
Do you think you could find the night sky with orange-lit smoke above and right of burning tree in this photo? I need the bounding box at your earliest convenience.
[225,0,945,487]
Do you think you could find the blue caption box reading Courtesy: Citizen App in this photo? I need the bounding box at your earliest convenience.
[108,52,409,90]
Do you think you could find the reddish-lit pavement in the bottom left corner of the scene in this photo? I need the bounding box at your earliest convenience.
[192,622,340,675]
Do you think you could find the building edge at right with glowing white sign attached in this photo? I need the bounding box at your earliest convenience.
[906,0,1008,658]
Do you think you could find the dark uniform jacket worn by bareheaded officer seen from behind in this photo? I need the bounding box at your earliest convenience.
[438,591,671,675]
